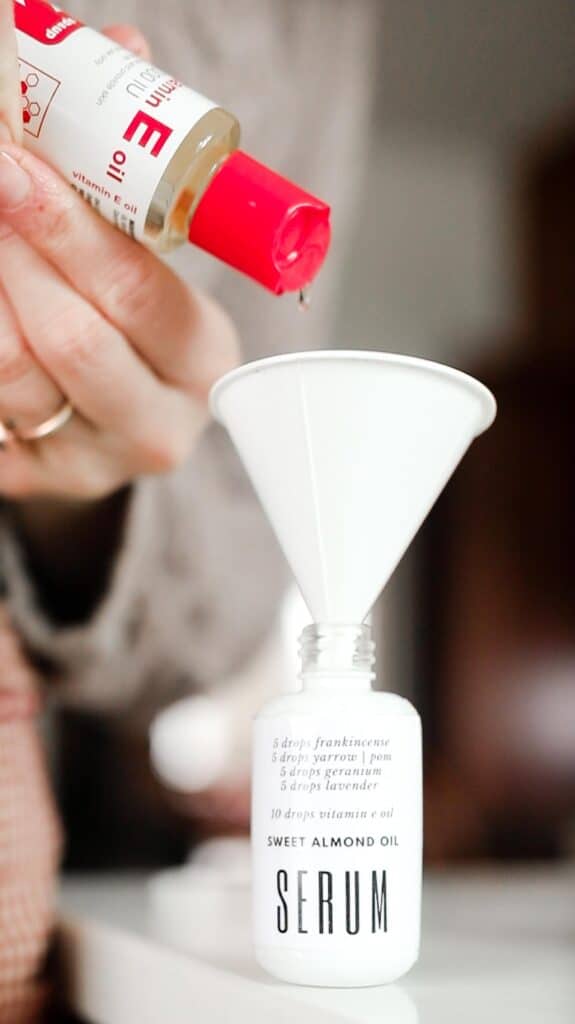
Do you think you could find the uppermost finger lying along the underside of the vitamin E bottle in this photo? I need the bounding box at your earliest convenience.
[0,147,237,397]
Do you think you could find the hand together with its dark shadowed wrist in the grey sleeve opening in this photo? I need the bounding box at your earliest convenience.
[0,8,236,651]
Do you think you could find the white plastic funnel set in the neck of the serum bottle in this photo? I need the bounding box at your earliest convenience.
[211,351,495,624]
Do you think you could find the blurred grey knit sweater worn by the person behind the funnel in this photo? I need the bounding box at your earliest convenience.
[1,0,377,712]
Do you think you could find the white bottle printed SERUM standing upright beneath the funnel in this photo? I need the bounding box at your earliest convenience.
[252,626,422,986]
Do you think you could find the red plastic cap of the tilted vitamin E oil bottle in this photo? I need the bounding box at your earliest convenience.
[188,151,329,295]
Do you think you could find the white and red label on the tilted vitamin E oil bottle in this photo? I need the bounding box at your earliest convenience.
[14,0,215,240]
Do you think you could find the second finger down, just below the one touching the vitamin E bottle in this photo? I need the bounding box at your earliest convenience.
[0,232,204,460]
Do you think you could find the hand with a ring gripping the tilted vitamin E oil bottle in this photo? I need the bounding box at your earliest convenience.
[0,12,237,499]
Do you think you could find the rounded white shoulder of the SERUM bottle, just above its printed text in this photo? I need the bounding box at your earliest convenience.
[256,690,419,721]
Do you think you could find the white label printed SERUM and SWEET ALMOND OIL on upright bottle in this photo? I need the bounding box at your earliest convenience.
[252,715,422,952]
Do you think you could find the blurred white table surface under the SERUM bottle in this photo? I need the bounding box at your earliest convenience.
[60,867,575,1024]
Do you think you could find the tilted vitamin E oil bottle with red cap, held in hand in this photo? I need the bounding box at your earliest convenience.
[14,0,329,294]
